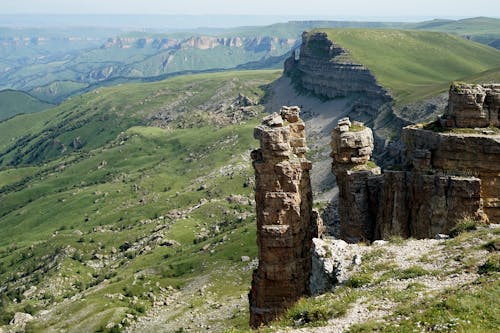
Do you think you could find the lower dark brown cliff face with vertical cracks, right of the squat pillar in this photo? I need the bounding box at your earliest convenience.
[368,171,482,239]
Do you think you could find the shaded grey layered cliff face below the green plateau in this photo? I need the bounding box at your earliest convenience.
[284,31,409,164]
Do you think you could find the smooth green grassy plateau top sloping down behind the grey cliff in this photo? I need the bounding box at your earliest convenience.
[313,29,500,104]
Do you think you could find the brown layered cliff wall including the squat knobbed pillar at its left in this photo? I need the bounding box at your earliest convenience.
[332,119,488,242]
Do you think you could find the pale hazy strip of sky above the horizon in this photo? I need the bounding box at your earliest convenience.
[0,0,500,18]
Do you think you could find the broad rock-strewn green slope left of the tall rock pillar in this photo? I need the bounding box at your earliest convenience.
[0,71,280,331]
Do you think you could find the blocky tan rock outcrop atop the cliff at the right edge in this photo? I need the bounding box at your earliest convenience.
[442,83,500,128]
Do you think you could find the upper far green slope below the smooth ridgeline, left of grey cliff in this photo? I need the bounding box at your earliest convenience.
[0,71,279,165]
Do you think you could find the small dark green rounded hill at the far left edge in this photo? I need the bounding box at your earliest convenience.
[0,90,53,121]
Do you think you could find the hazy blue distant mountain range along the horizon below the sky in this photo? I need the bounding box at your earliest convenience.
[0,17,500,103]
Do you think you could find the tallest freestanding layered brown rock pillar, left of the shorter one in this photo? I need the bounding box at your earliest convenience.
[249,107,318,327]
